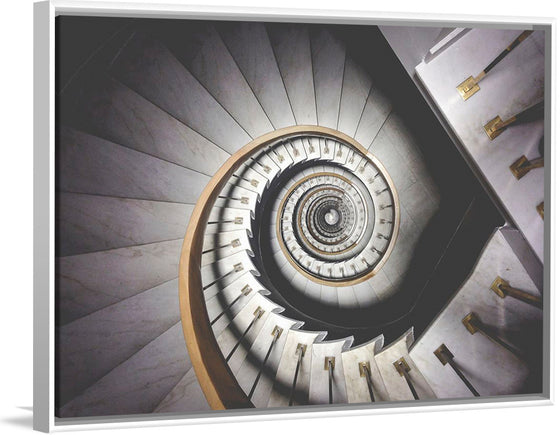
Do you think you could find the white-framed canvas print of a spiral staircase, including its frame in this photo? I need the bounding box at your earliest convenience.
[34,1,553,431]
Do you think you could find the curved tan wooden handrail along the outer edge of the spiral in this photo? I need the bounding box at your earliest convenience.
[179,125,394,410]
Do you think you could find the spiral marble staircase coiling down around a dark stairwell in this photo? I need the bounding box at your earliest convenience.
[56,17,543,420]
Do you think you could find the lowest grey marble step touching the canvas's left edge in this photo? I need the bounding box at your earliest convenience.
[57,279,180,405]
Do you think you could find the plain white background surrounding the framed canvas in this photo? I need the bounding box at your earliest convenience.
[0,0,560,435]
